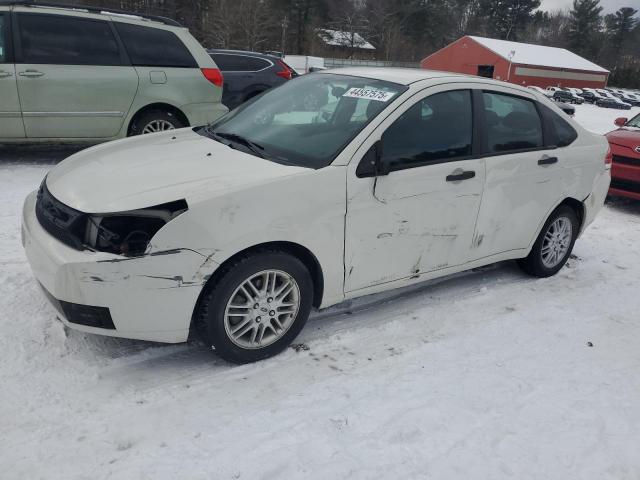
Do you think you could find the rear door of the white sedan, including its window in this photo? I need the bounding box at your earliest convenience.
[472,87,566,259]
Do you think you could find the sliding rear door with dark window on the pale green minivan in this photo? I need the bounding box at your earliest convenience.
[14,12,138,138]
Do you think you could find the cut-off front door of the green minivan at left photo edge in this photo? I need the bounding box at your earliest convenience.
[0,7,24,138]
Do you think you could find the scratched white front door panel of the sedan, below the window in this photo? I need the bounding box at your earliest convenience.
[345,159,484,291]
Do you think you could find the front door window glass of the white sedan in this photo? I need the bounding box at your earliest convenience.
[382,90,473,170]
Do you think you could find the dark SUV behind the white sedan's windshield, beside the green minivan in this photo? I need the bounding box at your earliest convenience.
[208,49,297,110]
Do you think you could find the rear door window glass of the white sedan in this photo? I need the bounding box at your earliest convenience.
[482,92,544,153]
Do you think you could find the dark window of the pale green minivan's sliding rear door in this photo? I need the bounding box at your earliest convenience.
[16,13,122,65]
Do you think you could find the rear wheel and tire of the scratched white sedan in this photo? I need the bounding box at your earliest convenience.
[518,205,580,278]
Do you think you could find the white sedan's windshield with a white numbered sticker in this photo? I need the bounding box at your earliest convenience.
[198,73,407,168]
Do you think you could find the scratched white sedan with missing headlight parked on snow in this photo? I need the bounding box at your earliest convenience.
[23,68,611,362]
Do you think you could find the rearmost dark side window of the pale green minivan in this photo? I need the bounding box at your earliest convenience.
[114,22,198,68]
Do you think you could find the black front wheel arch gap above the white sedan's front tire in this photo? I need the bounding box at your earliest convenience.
[192,242,324,332]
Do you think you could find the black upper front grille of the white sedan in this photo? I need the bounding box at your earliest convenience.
[36,182,88,250]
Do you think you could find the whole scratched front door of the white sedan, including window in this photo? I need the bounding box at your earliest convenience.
[345,84,485,293]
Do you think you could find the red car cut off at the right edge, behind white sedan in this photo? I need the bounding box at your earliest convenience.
[606,115,640,200]
